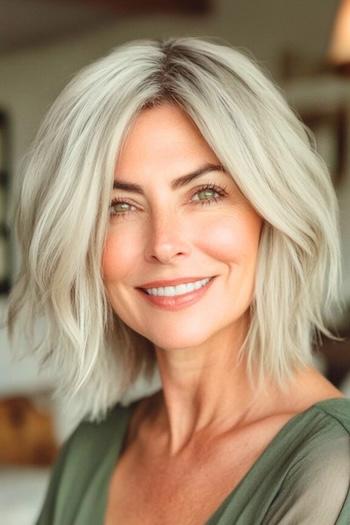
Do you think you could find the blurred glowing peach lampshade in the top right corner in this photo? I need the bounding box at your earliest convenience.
[328,0,350,66]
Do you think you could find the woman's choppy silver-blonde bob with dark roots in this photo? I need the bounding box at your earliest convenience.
[6,37,342,420]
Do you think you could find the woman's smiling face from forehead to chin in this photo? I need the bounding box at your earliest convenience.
[102,104,262,349]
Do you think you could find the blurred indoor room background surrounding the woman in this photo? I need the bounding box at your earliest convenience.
[0,0,350,525]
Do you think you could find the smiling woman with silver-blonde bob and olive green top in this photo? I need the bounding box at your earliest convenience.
[8,37,350,525]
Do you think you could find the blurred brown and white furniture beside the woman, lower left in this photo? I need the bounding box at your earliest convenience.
[0,392,58,525]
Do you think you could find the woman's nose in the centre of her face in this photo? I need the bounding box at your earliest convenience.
[145,209,191,264]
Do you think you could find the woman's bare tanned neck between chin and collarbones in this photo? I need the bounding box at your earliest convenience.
[151,332,268,456]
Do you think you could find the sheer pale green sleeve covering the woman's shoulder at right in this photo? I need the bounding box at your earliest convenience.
[263,398,350,525]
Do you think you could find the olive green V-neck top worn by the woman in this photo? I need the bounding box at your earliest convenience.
[36,398,350,525]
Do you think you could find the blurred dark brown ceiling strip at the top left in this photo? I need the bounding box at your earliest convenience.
[0,0,210,54]
